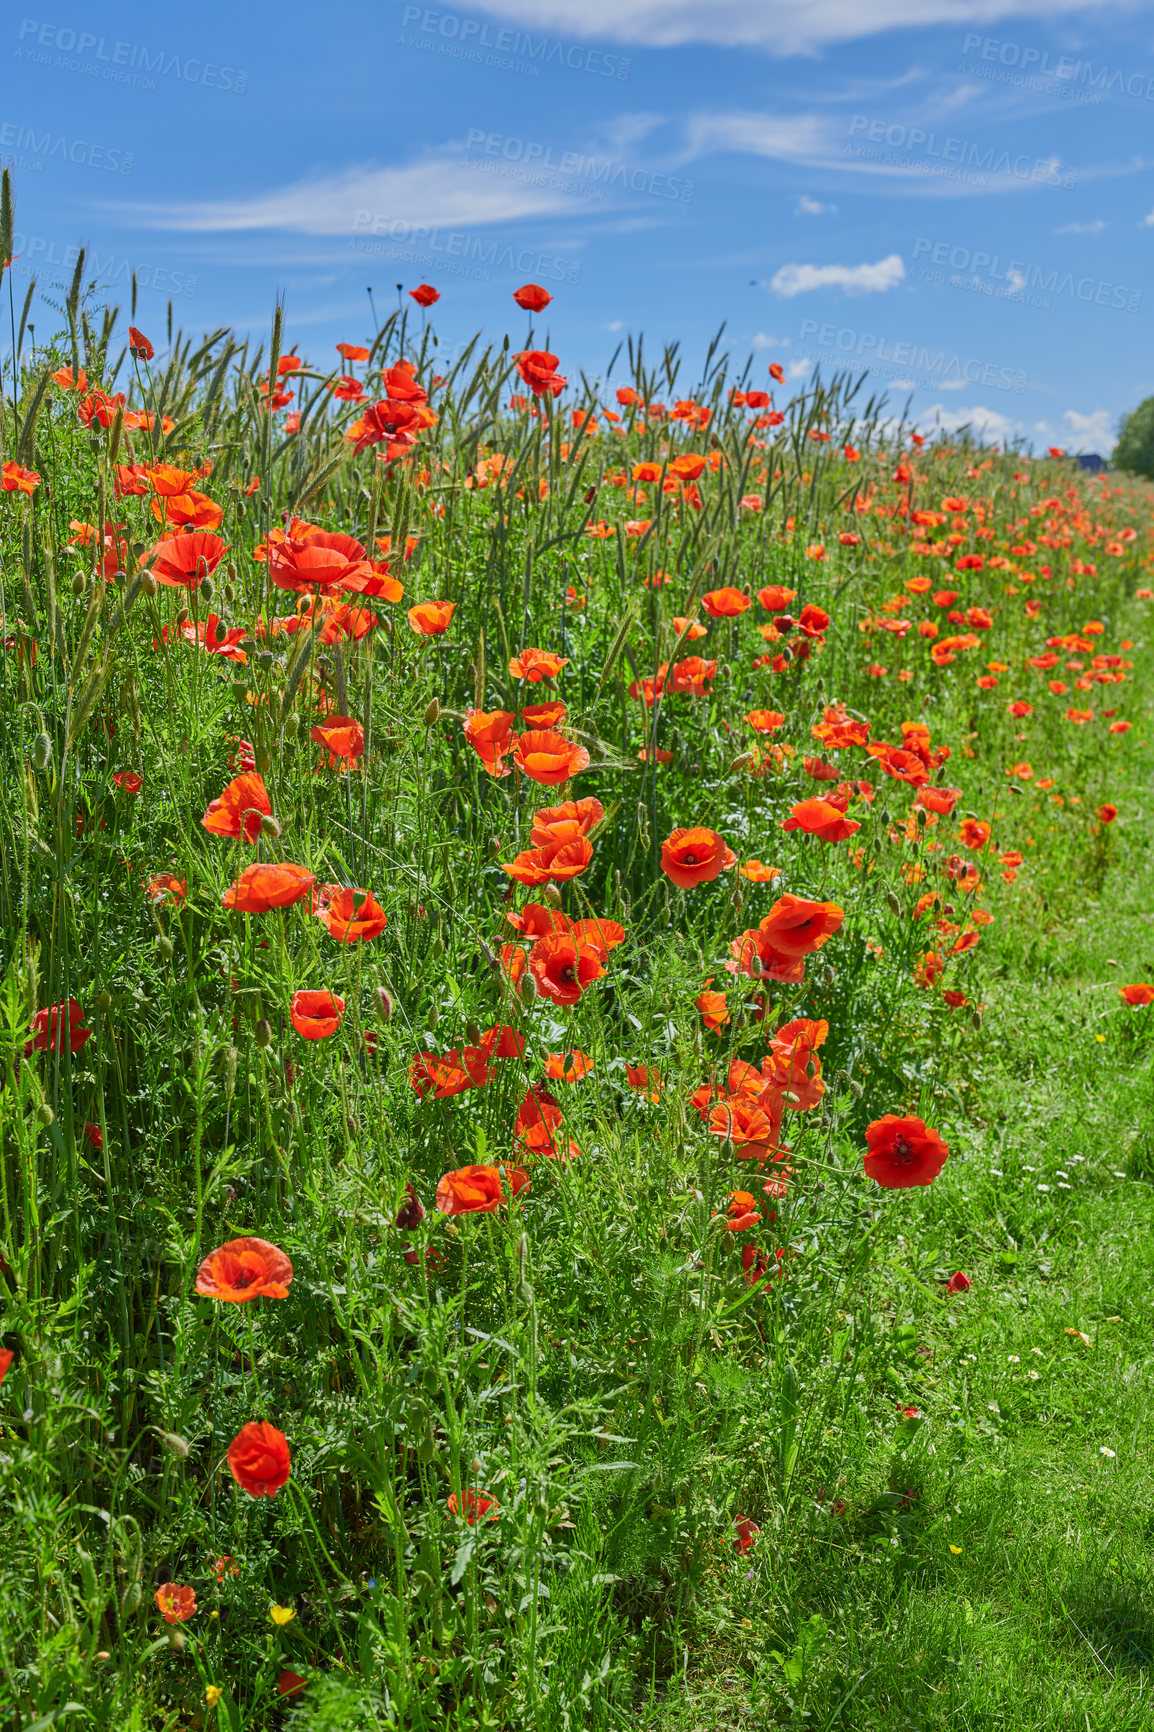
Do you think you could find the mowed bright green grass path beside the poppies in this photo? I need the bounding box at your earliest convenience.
[655,821,1154,1732]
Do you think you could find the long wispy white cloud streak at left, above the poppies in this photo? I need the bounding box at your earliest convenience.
[116,154,574,239]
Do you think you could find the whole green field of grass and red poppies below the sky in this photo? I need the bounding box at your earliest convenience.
[0,185,1154,1732]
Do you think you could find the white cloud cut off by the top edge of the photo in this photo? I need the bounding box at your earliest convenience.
[475,0,1115,54]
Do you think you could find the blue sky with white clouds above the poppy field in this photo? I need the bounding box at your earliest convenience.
[0,0,1154,452]
